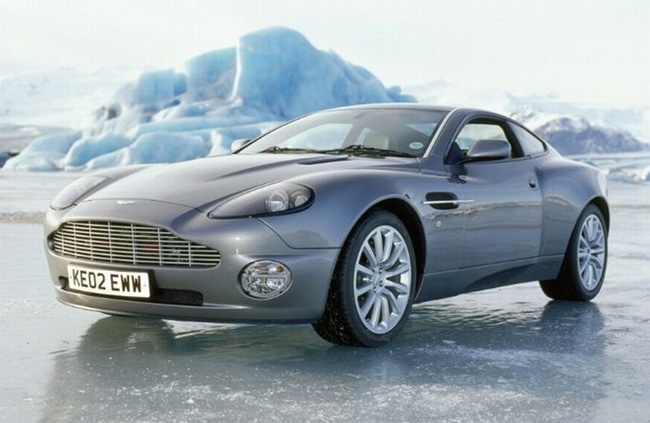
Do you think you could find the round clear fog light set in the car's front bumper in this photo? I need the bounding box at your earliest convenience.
[240,260,291,300]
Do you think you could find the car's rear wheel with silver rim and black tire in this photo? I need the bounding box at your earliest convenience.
[539,204,608,301]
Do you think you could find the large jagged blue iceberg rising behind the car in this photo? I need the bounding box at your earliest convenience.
[5,28,415,171]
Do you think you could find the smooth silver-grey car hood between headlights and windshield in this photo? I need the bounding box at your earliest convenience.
[83,154,413,211]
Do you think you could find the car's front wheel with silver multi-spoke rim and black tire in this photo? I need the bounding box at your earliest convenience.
[313,211,417,347]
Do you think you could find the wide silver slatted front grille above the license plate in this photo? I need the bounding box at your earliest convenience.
[51,221,221,267]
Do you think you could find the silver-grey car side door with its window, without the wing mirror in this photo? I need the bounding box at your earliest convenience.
[446,118,542,268]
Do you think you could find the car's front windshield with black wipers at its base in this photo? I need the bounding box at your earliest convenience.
[237,108,446,157]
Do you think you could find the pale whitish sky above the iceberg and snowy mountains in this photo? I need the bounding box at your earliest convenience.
[0,0,650,108]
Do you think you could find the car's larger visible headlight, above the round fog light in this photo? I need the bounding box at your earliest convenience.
[208,182,314,219]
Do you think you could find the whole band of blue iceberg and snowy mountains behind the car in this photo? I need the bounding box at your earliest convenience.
[0,27,650,180]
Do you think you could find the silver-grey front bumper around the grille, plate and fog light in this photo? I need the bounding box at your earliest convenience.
[45,200,339,322]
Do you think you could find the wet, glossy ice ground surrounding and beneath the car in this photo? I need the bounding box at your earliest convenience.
[0,175,650,422]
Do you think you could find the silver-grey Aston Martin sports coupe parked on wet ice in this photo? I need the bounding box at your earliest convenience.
[45,104,609,347]
